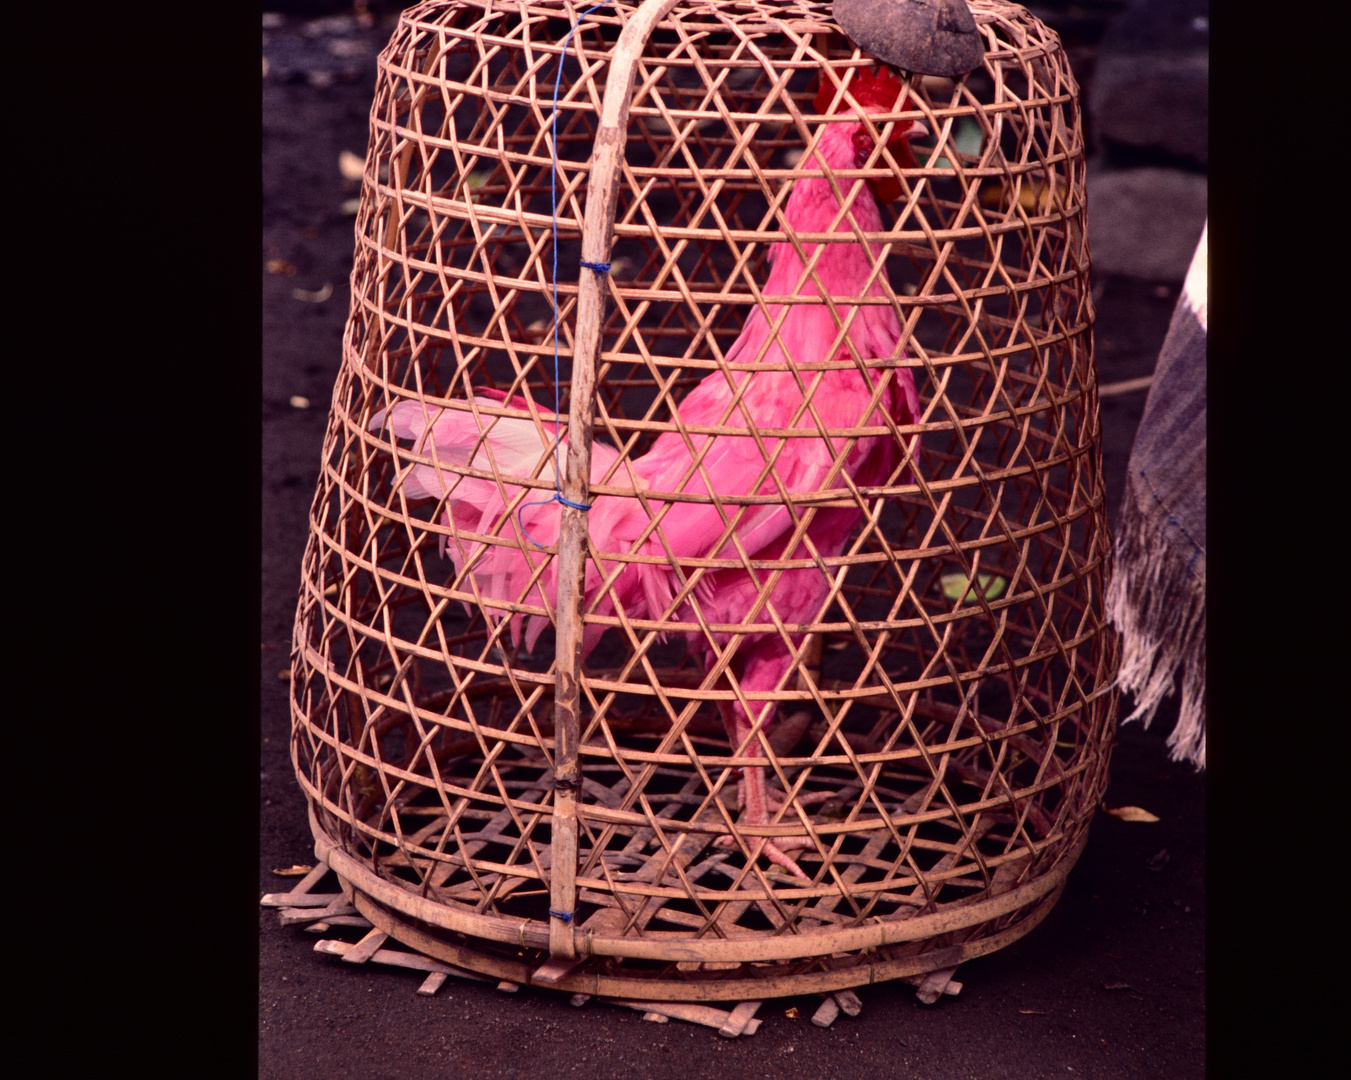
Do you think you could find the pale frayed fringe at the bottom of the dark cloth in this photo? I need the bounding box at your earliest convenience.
[1106,484,1205,769]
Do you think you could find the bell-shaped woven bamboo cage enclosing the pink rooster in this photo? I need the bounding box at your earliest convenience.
[292,0,1117,1002]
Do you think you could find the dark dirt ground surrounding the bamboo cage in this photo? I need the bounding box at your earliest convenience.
[257,4,1206,1080]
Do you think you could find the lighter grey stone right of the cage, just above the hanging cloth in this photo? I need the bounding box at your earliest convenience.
[1086,165,1206,283]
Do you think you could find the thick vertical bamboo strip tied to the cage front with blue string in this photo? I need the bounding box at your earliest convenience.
[549,0,680,958]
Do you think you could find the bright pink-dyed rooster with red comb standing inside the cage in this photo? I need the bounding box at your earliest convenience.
[370,69,925,880]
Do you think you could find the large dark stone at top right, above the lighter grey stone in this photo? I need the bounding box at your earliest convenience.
[1088,0,1210,165]
